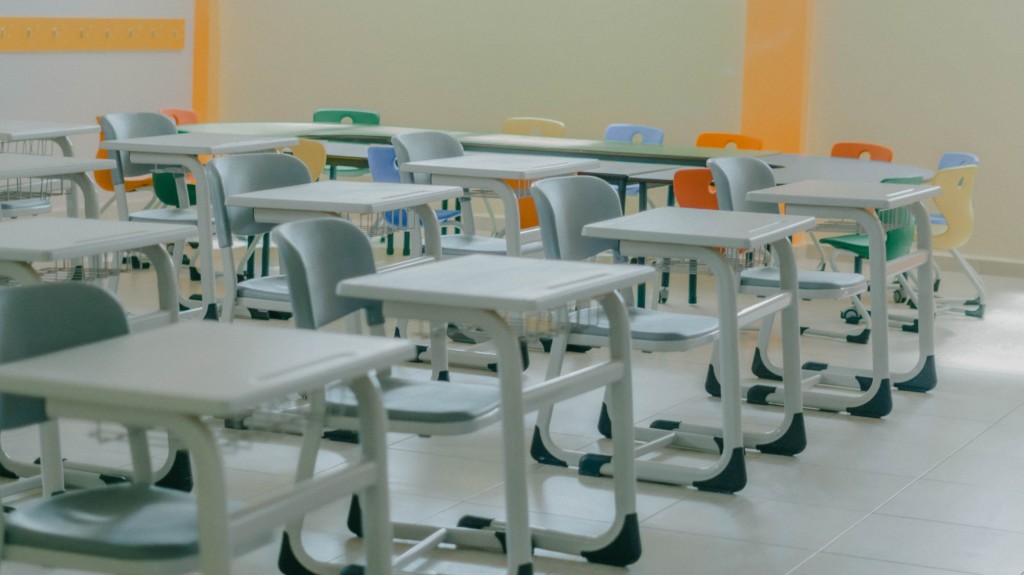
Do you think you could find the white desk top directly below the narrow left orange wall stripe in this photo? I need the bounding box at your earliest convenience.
[99,133,299,156]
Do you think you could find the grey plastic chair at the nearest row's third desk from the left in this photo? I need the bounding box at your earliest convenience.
[530,176,718,437]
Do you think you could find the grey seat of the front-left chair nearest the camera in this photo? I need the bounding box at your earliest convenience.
[4,485,199,560]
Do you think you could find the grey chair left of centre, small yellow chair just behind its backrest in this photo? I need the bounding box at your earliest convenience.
[206,153,310,321]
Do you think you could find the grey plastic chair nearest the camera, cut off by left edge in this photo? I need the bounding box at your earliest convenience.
[0,282,211,572]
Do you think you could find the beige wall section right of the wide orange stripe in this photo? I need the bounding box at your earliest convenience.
[807,0,1024,268]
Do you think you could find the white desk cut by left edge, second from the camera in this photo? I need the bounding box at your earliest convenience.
[0,218,196,329]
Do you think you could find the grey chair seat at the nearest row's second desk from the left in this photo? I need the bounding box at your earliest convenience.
[327,375,501,424]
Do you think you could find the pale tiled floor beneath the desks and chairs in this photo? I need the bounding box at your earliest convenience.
[3,226,1024,575]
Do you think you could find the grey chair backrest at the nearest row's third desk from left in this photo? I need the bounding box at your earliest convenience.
[530,171,623,261]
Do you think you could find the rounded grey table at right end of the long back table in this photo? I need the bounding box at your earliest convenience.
[760,153,934,184]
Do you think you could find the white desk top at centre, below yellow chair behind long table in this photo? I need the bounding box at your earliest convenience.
[398,153,600,180]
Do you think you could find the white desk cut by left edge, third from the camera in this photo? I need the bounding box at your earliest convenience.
[0,153,116,219]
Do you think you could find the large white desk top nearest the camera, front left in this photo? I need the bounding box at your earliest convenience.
[0,321,414,416]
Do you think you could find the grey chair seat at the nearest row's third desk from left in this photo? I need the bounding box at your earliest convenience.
[569,308,718,344]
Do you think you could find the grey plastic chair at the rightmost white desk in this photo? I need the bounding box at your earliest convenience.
[708,158,871,382]
